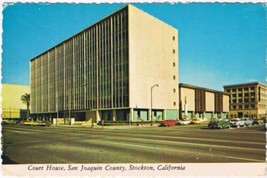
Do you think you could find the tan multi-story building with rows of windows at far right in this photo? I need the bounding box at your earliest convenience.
[224,82,267,118]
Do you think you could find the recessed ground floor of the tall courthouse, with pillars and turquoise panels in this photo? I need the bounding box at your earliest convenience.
[31,108,178,124]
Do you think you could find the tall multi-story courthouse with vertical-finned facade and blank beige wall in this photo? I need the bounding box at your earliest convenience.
[30,5,179,122]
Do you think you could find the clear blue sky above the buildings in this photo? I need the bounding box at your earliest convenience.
[2,3,266,90]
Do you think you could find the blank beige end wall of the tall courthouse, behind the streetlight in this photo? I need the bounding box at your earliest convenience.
[129,5,179,109]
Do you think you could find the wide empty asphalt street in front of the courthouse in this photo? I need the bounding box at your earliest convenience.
[2,123,266,164]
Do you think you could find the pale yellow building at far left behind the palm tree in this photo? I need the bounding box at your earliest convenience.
[1,84,30,119]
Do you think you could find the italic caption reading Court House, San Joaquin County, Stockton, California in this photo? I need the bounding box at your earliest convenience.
[28,164,185,172]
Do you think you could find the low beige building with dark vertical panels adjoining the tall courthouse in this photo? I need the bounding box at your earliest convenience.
[179,83,229,119]
